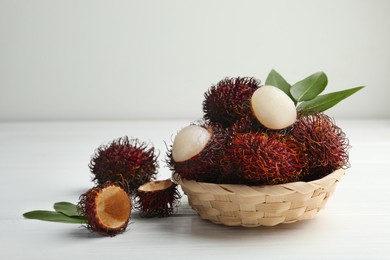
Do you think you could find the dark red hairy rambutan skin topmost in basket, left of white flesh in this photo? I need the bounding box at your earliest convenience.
[203,77,261,128]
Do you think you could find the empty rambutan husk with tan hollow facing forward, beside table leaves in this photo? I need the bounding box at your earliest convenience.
[78,182,131,236]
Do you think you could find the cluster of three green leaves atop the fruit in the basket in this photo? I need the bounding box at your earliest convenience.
[265,70,364,112]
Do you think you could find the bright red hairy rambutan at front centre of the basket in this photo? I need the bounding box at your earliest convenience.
[218,132,307,185]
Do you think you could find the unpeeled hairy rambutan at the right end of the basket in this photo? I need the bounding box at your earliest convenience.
[292,113,350,180]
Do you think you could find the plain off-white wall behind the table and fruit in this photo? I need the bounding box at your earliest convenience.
[0,0,390,121]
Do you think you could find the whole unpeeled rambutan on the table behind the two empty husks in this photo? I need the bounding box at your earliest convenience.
[89,136,158,192]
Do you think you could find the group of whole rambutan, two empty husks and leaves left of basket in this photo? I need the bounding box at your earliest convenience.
[23,136,181,236]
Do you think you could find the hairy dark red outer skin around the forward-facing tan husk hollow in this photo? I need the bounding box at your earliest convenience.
[77,182,131,237]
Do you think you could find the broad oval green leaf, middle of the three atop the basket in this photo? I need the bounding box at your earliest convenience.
[290,72,328,102]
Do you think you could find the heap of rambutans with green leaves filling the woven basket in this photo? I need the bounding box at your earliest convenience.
[167,70,363,185]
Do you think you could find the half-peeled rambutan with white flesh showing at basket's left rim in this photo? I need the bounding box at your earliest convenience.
[167,123,226,182]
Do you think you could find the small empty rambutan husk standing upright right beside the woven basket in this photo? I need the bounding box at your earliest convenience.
[134,179,181,218]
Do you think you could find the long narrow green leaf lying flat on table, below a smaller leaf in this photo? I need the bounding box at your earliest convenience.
[23,210,87,224]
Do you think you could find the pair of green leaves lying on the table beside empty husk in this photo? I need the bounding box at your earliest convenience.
[23,202,87,224]
